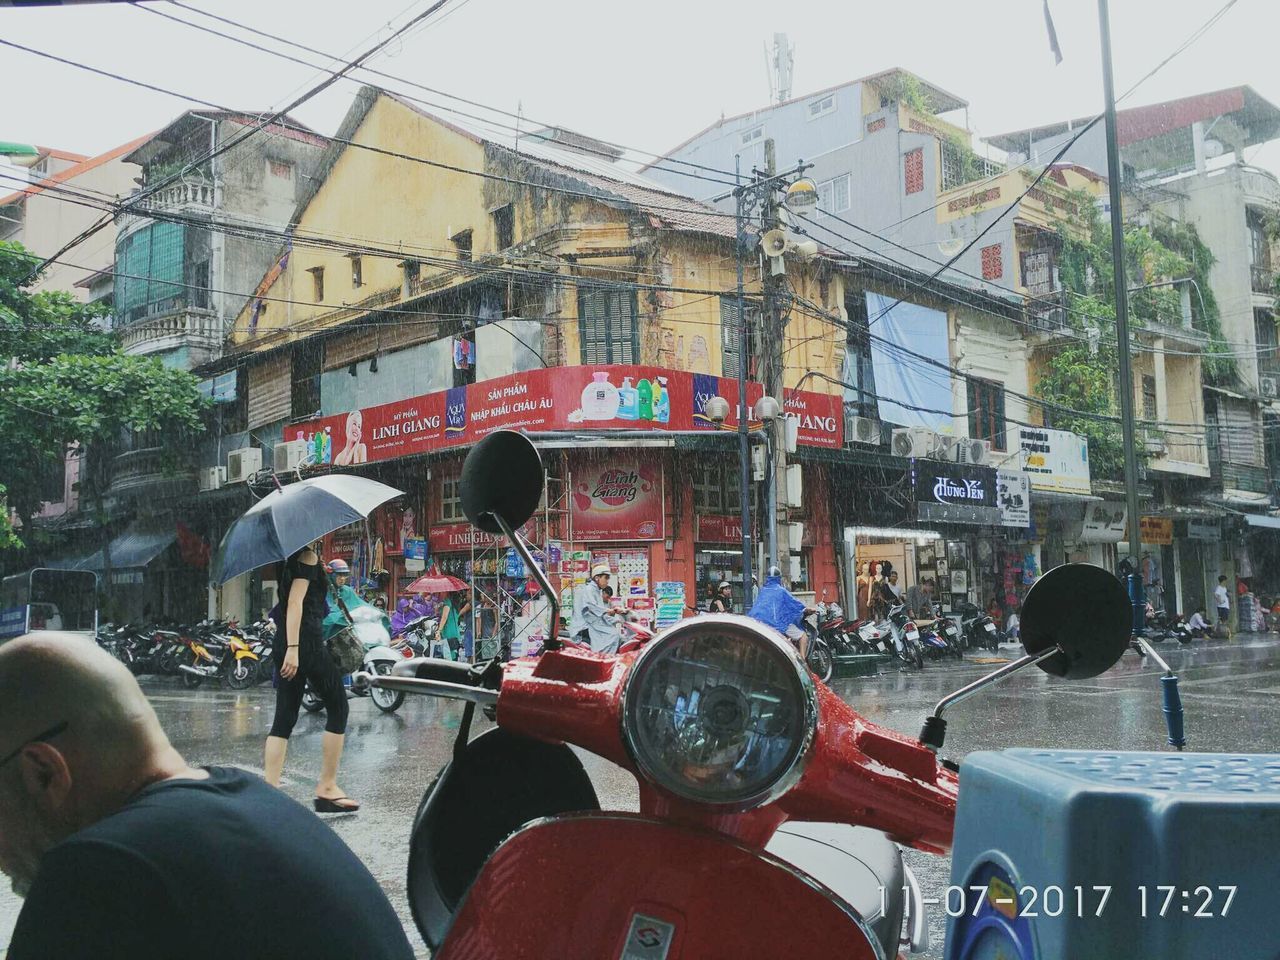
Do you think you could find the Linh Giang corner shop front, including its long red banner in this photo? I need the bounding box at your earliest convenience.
[289,366,844,660]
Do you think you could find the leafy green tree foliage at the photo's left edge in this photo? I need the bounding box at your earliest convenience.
[0,243,204,549]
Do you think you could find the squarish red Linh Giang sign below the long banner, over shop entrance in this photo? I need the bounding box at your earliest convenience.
[572,453,664,543]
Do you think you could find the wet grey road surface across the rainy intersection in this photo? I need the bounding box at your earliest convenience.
[0,636,1280,957]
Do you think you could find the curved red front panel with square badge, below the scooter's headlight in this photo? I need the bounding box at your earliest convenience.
[435,814,886,960]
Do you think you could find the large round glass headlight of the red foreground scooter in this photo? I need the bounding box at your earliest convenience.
[622,614,818,810]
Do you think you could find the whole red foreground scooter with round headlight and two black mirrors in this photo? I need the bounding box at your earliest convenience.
[357,431,1128,960]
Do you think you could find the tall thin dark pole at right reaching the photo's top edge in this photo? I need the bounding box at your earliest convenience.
[1098,0,1146,631]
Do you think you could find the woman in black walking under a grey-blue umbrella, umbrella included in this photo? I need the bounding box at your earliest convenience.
[215,475,402,813]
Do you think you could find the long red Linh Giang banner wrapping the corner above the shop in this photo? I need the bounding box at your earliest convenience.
[284,365,844,466]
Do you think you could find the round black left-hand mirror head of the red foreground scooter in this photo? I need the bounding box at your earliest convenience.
[458,430,544,534]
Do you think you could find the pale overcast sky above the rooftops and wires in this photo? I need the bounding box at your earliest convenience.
[0,0,1280,188]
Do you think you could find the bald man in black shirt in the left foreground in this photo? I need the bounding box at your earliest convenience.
[0,634,413,960]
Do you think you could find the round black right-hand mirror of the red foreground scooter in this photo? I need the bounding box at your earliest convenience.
[1020,563,1133,680]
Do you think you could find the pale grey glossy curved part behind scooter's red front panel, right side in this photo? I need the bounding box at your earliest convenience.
[765,820,905,956]
